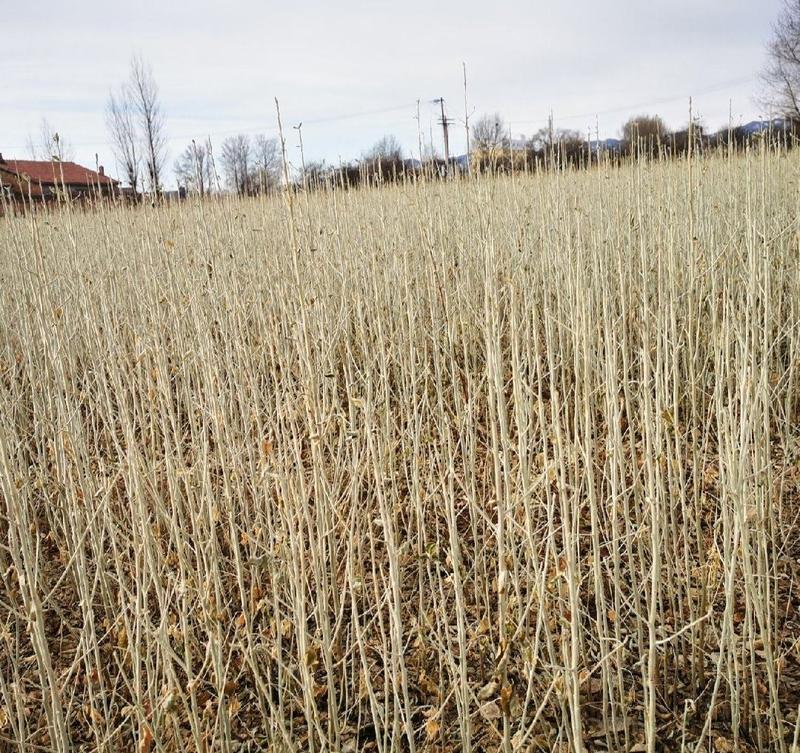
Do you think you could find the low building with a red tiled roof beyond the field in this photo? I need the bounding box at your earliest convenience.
[0,154,119,209]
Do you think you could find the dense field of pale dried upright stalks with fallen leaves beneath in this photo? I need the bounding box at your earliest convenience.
[0,151,800,753]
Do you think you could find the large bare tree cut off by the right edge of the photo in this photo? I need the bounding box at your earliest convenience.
[761,0,800,120]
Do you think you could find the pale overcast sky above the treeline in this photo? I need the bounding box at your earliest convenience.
[0,0,781,187]
